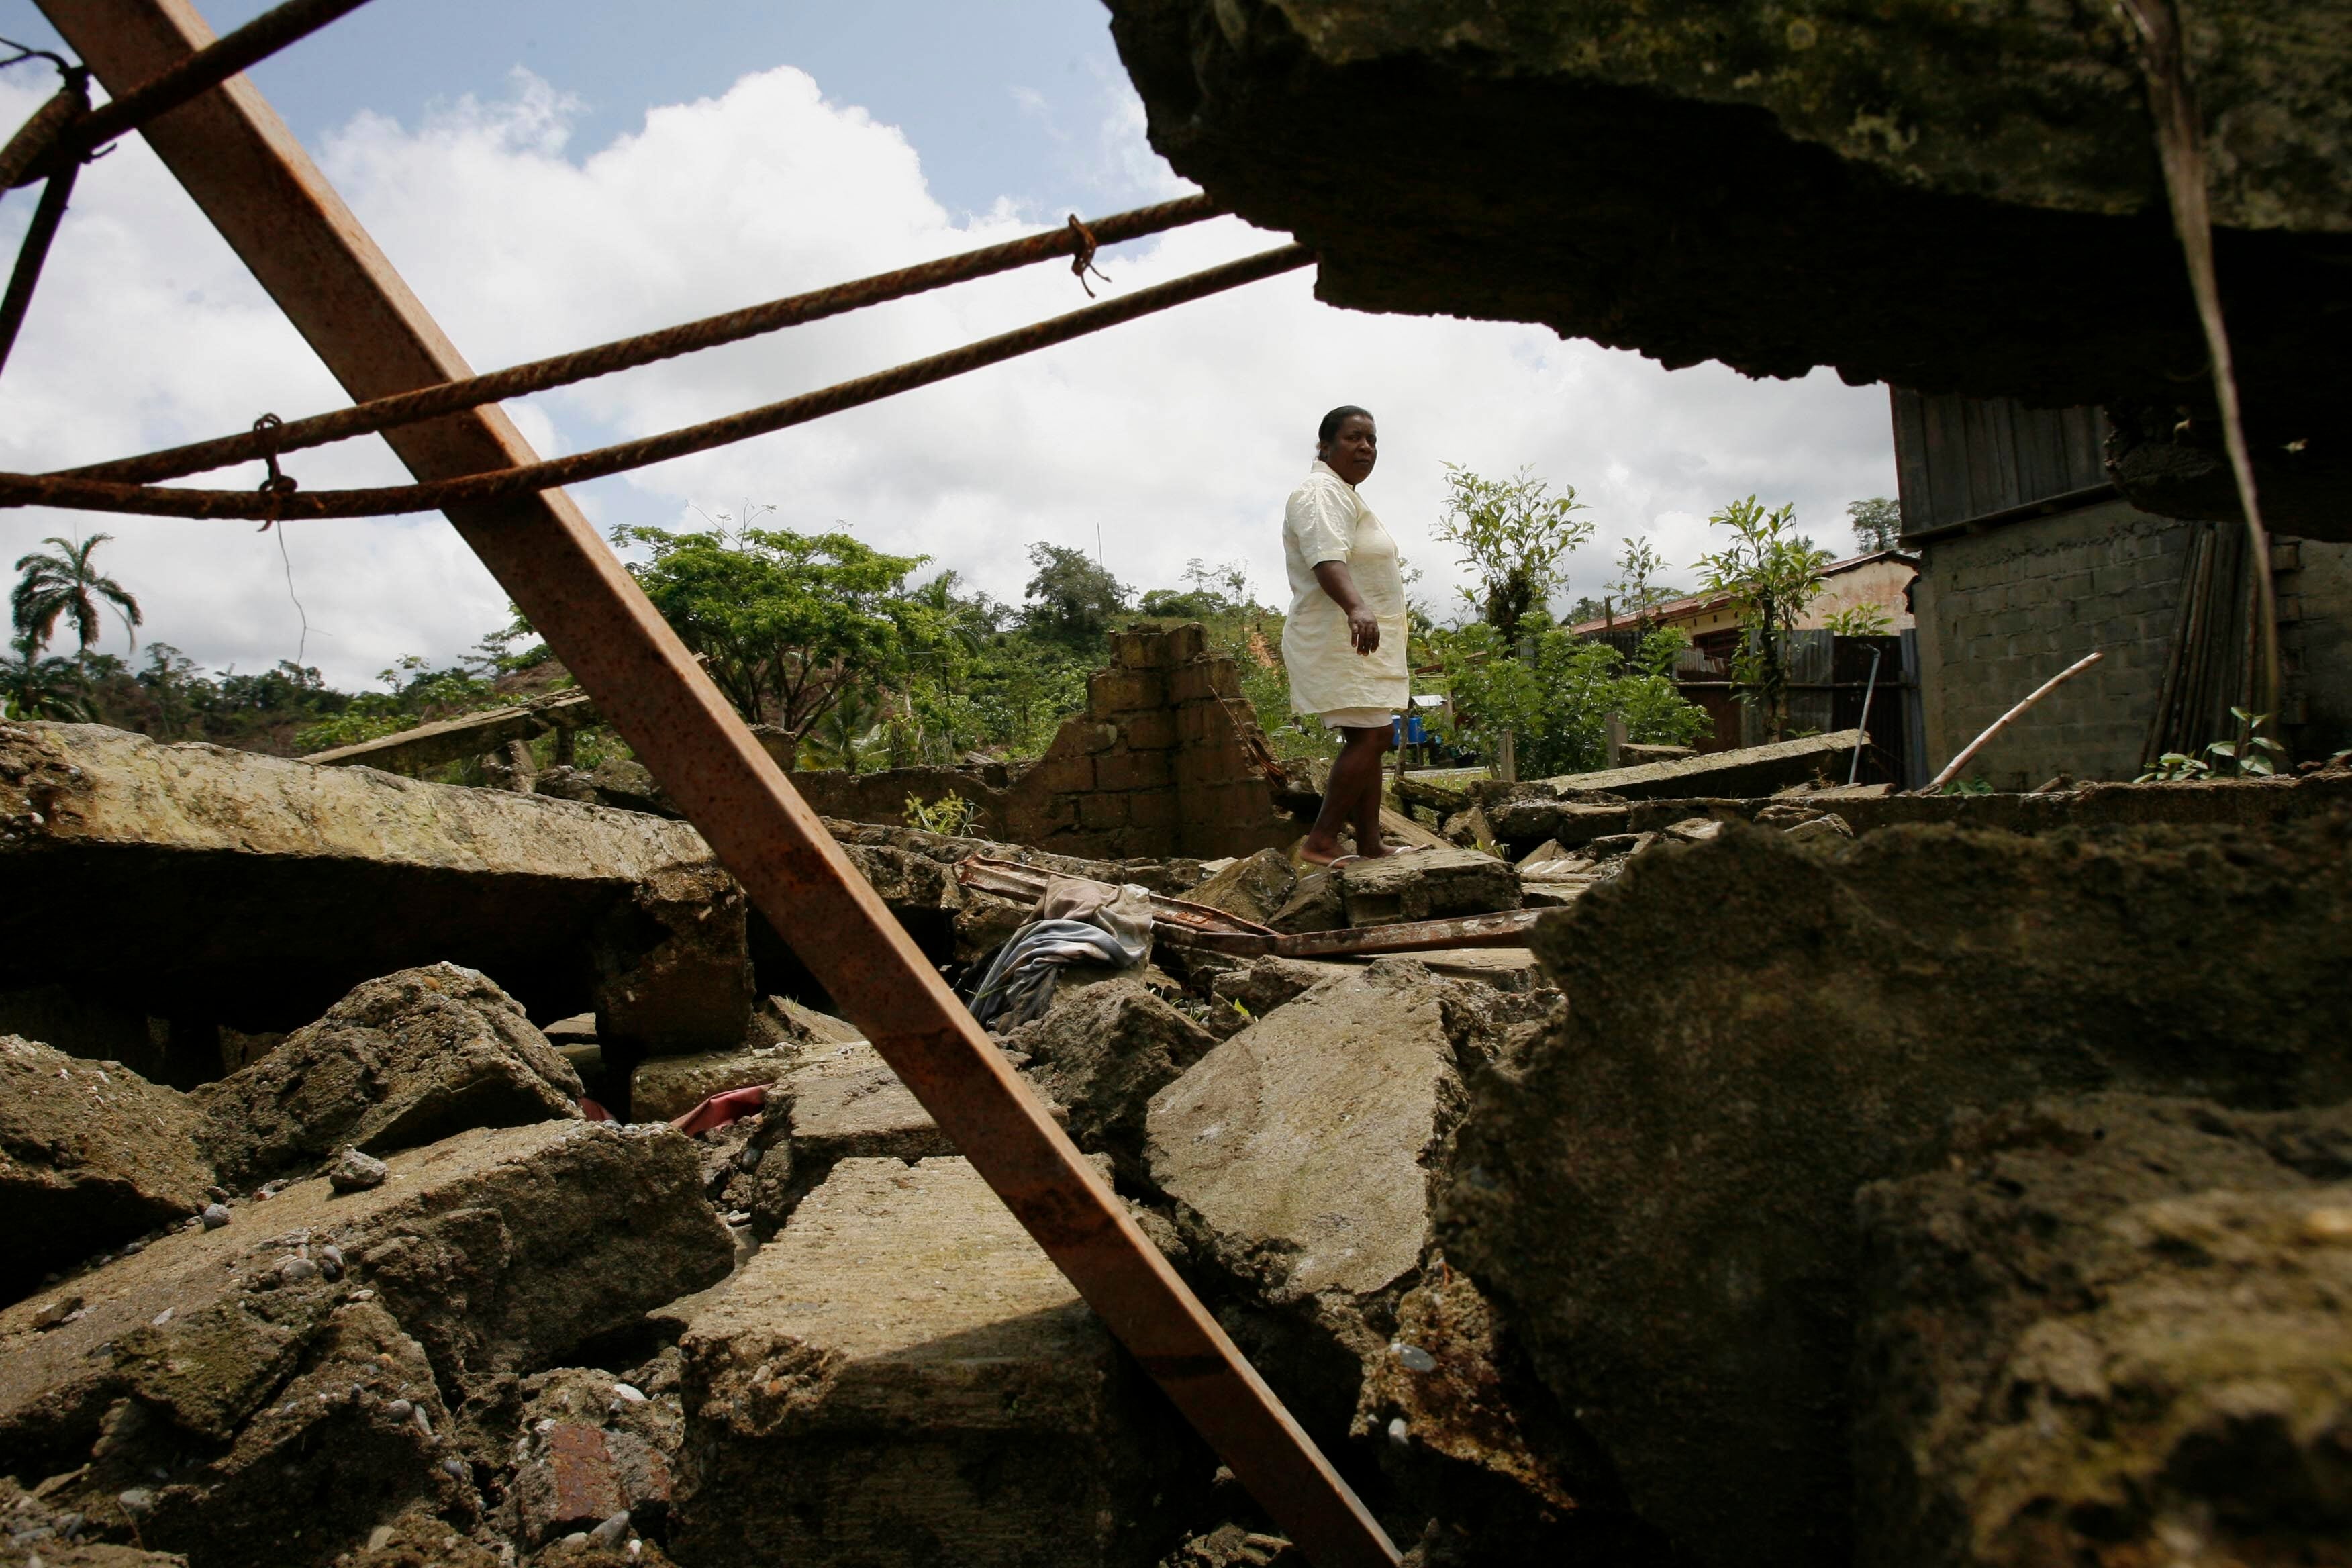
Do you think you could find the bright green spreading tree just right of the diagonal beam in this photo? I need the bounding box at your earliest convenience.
[614,527,929,754]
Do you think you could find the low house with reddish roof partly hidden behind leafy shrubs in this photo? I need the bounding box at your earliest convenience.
[1569,550,1924,787]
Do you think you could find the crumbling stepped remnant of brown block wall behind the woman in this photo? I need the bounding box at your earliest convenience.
[1004,626,1298,861]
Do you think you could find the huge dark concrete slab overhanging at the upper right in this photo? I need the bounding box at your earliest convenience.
[1110,0,2352,527]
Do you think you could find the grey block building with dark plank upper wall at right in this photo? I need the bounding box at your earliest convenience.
[1891,388,2352,790]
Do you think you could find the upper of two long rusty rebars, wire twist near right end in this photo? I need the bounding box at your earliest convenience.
[66,195,1223,484]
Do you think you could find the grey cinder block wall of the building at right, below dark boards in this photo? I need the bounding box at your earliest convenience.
[1912,501,2352,790]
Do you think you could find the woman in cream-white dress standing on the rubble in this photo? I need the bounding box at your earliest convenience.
[1282,407,1411,865]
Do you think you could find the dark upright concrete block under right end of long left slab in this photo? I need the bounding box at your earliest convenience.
[593,863,752,1056]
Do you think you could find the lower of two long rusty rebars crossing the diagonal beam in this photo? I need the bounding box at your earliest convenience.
[0,244,1315,522]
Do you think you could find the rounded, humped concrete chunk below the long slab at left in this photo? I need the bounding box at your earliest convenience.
[193,964,583,1187]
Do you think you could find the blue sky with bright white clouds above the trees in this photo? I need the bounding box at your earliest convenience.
[0,0,1894,687]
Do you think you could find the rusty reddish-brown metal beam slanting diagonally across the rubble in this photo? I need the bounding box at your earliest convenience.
[40,0,1397,1568]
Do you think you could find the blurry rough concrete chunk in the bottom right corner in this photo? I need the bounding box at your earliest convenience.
[1853,1095,2352,1568]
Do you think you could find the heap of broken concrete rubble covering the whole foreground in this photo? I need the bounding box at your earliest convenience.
[0,726,2352,1568]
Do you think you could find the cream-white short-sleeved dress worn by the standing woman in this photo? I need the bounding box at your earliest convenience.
[1282,460,1411,712]
